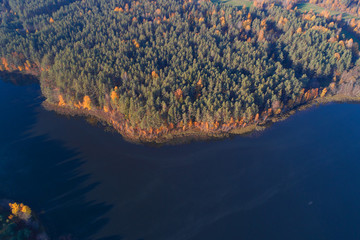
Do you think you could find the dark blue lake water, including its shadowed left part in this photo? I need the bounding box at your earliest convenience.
[0,78,360,240]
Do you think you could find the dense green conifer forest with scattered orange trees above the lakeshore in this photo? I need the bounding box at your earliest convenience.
[0,0,358,132]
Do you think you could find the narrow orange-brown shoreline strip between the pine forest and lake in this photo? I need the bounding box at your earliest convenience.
[42,94,360,145]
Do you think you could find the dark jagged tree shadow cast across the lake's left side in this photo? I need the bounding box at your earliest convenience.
[0,77,121,240]
